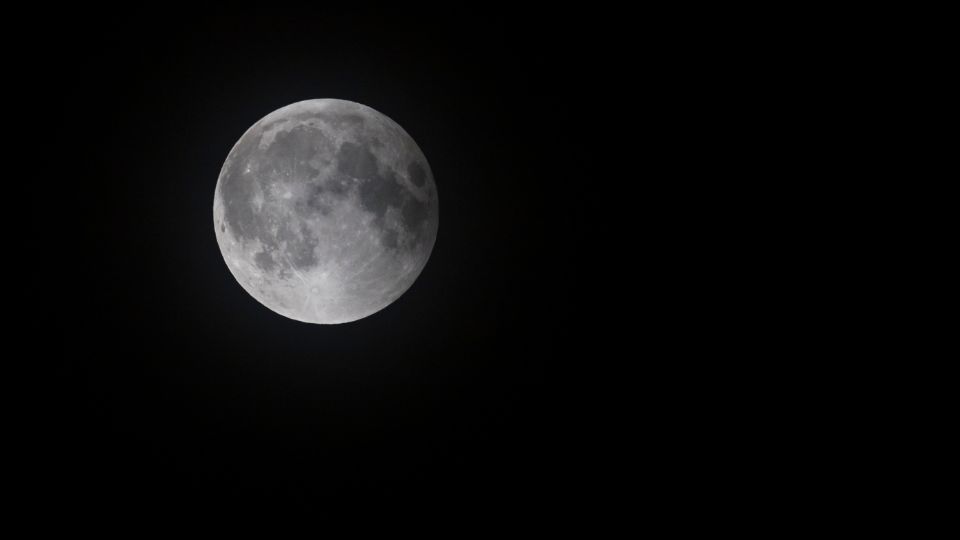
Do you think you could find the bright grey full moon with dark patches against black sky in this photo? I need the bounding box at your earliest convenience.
[213,99,439,324]
